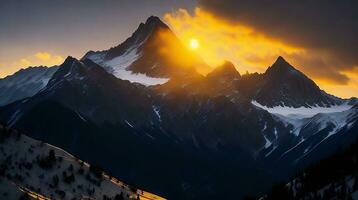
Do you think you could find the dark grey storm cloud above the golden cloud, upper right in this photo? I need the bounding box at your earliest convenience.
[199,0,358,83]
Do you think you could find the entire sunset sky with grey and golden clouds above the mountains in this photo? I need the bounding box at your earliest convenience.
[0,0,358,97]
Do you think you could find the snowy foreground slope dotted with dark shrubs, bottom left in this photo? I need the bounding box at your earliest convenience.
[0,125,163,200]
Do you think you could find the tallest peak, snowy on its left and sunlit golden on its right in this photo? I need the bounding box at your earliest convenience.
[83,16,209,86]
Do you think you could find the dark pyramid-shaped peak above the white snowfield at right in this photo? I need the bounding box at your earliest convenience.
[248,57,343,107]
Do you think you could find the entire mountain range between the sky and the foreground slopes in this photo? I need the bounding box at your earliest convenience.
[0,17,358,199]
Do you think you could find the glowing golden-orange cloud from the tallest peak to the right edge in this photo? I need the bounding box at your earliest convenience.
[164,8,358,97]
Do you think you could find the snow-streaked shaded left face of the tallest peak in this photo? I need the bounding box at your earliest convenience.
[83,17,173,86]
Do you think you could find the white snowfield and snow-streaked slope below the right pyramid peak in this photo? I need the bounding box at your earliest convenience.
[251,101,358,163]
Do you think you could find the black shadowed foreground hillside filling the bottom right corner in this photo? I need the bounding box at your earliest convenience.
[260,130,358,200]
